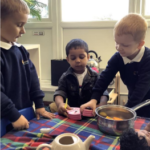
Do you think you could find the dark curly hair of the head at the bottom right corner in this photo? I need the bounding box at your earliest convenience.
[120,128,150,150]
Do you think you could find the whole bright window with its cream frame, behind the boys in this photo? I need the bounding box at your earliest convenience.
[28,0,150,28]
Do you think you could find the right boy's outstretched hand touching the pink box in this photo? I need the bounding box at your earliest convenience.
[80,99,97,116]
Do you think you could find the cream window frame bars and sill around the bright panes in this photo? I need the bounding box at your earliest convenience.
[25,0,150,29]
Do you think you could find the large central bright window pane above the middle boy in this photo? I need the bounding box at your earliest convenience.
[61,0,129,22]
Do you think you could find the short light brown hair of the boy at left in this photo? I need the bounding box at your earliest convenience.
[0,0,30,19]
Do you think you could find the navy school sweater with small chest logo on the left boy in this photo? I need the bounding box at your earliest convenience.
[0,45,44,122]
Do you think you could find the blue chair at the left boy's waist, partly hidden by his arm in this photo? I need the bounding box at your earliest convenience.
[0,107,35,137]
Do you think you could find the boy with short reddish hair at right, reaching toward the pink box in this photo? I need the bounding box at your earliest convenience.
[82,14,150,117]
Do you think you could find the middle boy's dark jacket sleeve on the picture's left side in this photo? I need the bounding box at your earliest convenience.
[54,73,67,102]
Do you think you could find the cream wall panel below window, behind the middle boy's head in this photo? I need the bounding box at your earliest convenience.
[63,29,116,68]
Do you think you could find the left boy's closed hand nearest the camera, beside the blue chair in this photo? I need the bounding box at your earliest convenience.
[12,115,29,130]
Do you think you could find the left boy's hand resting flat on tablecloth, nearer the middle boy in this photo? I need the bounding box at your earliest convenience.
[36,108,55,120]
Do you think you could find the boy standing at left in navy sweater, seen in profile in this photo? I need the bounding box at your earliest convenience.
[0,0,54,129]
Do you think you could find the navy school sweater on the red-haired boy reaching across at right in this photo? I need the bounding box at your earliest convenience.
[92,47,150,117]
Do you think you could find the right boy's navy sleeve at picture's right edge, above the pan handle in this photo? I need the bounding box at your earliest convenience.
[126,59,150,107]
